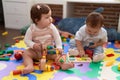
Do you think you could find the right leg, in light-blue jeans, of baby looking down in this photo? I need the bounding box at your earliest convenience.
[93,46,105,62]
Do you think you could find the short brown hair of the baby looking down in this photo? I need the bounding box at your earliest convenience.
[86,12,104,28]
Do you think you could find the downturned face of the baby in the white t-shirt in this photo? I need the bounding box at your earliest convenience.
[86,26,100,36]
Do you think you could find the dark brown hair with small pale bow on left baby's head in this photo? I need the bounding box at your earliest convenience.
[30,3,51,24]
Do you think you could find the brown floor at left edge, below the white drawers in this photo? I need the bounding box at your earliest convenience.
[0,25,21,49]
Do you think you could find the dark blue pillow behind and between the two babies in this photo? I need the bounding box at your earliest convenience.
[57,17,86,34]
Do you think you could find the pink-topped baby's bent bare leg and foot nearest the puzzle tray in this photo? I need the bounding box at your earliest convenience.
[56,55,74,70]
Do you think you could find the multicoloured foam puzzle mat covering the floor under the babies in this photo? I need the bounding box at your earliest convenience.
[0,40,120,80]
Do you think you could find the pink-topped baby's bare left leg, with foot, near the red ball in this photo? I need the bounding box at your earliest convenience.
[22,49,38,74]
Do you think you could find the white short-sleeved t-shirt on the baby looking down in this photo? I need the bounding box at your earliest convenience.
[75,25,108,47]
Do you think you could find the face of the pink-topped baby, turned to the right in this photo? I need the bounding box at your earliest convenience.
[37,10,52,28]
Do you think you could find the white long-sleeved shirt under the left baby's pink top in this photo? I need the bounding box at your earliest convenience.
[24,24,62,49]
